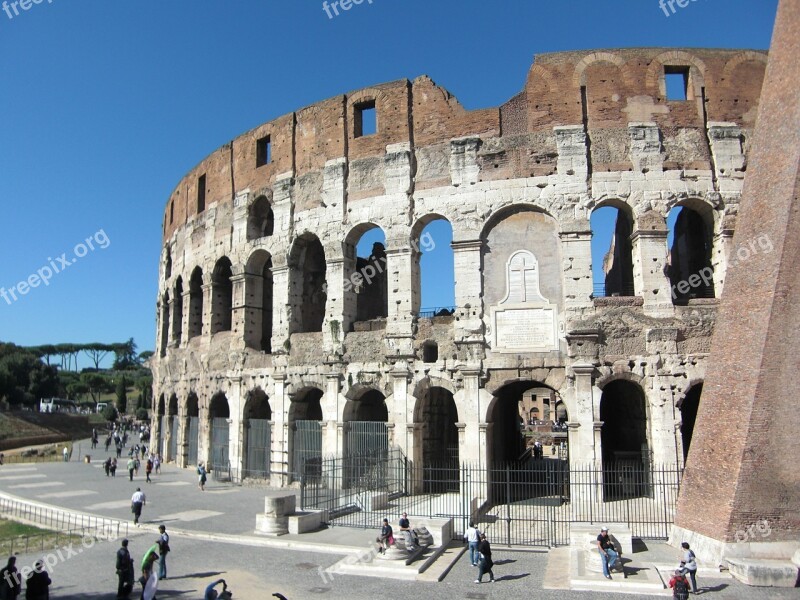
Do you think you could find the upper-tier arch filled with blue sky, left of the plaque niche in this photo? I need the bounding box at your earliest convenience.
[411,214,456,318]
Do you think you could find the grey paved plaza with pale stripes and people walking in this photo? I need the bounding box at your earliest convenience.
[0,452,800,600]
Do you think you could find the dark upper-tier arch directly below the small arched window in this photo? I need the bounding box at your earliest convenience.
[245,250,273,354]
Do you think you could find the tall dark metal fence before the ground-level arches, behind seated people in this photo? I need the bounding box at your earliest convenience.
[300,450,682,546]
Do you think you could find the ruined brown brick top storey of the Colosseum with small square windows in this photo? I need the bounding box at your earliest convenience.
[159,48,767,240]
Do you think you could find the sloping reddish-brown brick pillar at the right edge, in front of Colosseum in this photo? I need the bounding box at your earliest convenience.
[671,0,800,572]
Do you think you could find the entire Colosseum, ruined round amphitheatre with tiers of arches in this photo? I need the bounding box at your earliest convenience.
[151,48,767,544]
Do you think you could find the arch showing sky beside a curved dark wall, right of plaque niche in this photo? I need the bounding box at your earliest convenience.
[591,205,635,298]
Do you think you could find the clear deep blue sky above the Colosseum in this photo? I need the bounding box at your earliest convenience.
[0,0,777,364]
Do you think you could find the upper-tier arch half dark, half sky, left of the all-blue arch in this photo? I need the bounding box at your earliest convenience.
[344,223,389,323]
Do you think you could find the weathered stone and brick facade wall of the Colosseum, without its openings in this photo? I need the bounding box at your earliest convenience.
[152,48,766,483]
